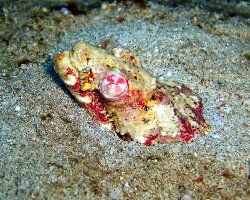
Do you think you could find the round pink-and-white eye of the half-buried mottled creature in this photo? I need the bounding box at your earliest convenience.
[99,73,128,101]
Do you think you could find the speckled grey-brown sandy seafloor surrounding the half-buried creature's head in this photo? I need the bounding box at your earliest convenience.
[0,2,250,200]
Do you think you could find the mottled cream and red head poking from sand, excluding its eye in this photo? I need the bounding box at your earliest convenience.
[55,42,208,146]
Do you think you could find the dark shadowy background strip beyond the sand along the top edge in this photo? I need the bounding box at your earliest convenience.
[0,0,250,17]
